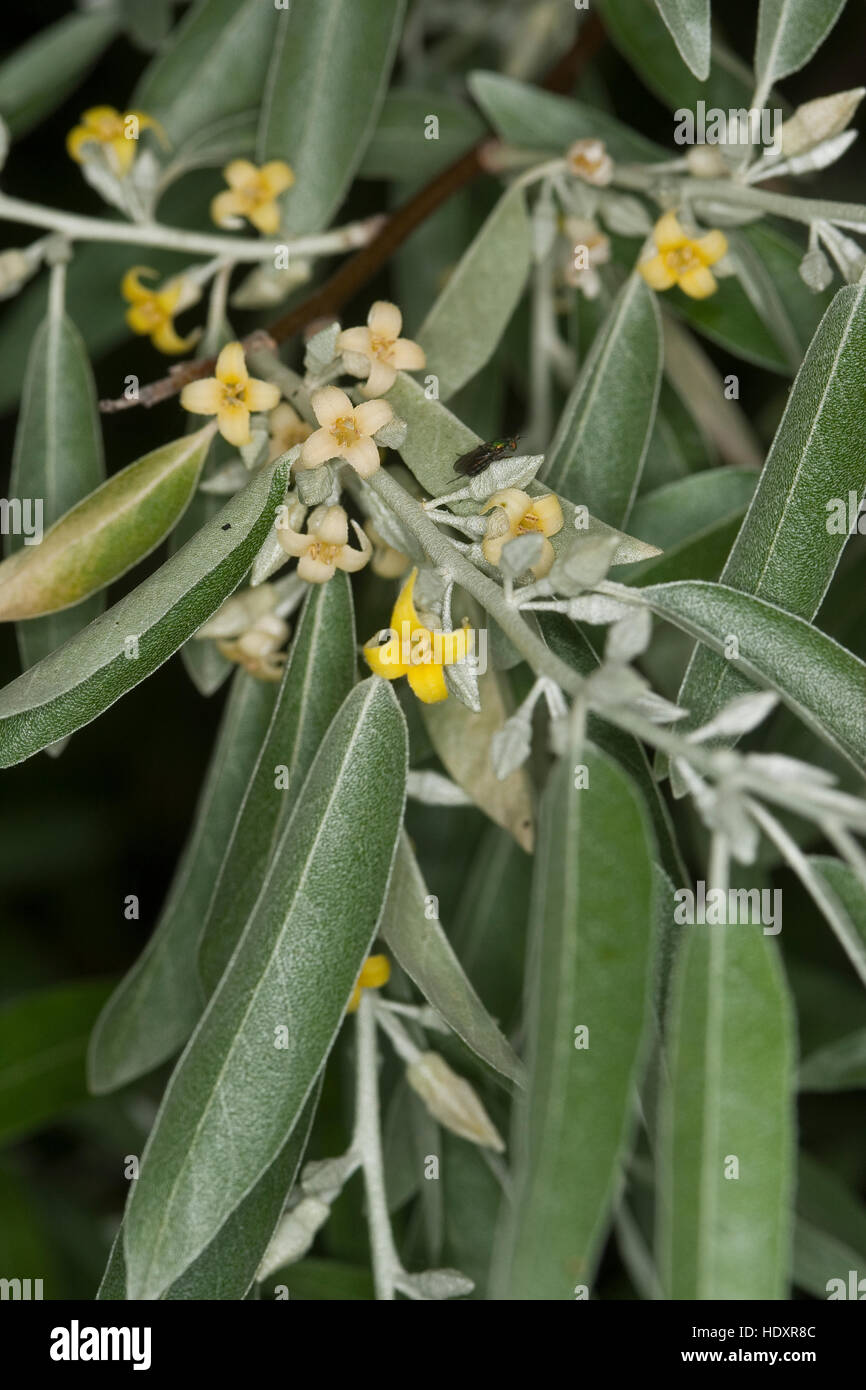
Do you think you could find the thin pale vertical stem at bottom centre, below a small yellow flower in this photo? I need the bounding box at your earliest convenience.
[352,990,402,1302]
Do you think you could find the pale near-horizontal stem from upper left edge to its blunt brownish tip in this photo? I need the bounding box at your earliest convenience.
[0,193,382,261]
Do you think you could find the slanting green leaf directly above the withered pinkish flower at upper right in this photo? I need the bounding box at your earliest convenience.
[467,72,669,164]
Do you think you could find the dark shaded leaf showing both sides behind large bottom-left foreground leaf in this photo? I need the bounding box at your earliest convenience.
[96,1079,321,1302]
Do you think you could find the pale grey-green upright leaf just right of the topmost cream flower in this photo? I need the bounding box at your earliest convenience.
[417,188,531,400]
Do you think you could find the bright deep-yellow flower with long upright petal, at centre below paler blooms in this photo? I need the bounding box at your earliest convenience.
[364,570,468,705]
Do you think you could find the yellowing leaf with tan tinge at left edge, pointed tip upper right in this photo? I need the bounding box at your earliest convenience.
[0,425,213,621]
